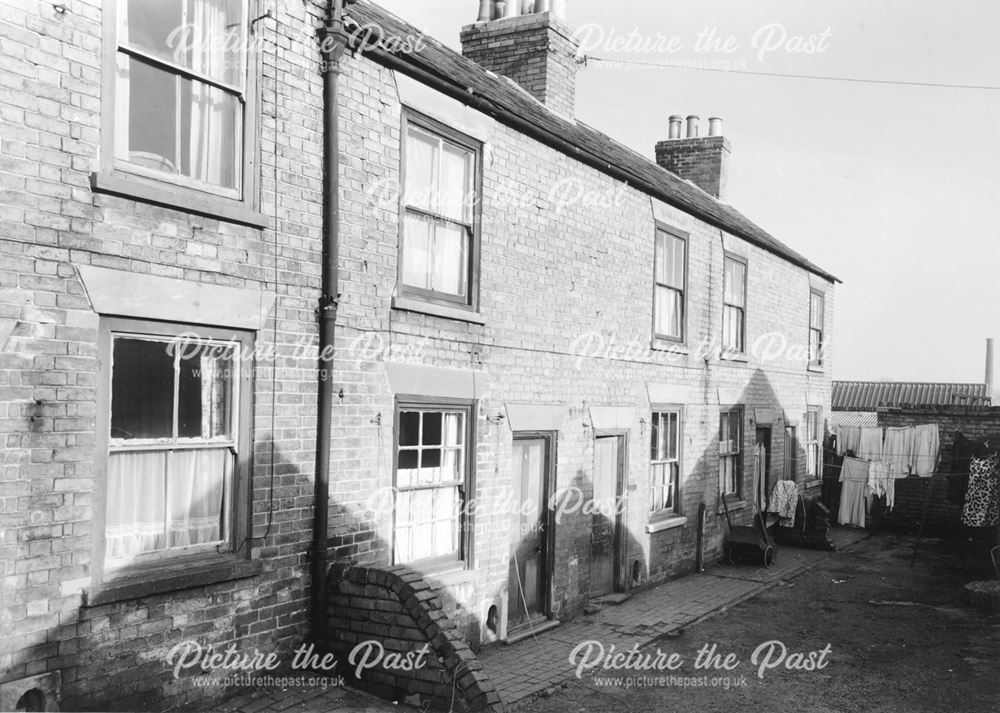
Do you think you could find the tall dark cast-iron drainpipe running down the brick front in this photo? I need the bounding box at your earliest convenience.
[311,0,350,644]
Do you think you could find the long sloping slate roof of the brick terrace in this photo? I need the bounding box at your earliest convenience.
[346,0,840,282]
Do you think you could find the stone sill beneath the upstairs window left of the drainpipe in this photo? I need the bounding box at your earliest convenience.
[90,171,270,228]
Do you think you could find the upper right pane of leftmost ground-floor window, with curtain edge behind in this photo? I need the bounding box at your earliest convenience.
[177,344,236,438]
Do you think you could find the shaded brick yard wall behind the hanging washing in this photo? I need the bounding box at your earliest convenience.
[878,406,1000,535]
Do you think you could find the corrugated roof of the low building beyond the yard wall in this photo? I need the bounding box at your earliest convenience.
[833,381,992,411]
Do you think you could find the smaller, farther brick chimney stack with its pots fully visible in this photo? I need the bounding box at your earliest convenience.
[656,115,732,200]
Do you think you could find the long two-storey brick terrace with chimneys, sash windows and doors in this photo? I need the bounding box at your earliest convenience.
[0,0,836,709]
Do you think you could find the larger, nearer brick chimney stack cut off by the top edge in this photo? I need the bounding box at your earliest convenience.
[461,0,580,118]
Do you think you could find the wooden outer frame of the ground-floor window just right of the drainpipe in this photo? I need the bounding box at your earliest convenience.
[391,395,478,572]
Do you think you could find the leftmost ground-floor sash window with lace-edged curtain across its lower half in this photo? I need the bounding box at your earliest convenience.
[101,319,251,571]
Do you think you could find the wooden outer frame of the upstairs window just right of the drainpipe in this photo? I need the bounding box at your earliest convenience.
[396,107,483,313]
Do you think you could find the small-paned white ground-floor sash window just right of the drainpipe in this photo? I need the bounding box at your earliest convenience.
[394,402,472,564]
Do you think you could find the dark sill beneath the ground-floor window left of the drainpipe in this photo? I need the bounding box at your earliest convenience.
[82,558,265,607]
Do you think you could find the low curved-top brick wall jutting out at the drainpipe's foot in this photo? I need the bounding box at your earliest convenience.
[327,562,504,713]
